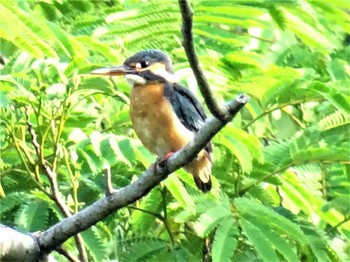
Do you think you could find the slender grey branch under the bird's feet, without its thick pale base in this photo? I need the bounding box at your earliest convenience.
[37,95,249,254]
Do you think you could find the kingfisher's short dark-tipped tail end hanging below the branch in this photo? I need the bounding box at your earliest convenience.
[185,150,212,193]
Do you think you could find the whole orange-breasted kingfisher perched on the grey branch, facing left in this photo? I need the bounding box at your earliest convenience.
[91,49,213,192]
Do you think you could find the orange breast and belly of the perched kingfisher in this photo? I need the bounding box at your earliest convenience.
[130,84,193,157]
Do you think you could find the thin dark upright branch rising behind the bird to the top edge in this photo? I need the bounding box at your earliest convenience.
[179,0,228,122]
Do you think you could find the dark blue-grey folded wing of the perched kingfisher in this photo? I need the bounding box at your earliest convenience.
[164,83,212,153]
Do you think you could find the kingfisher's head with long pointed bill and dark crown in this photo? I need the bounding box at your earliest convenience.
[91,49,176,86]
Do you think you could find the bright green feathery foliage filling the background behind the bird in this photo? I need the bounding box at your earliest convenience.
[0,0,350,262]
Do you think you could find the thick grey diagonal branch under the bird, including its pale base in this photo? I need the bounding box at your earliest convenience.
[0,95,249,261]
